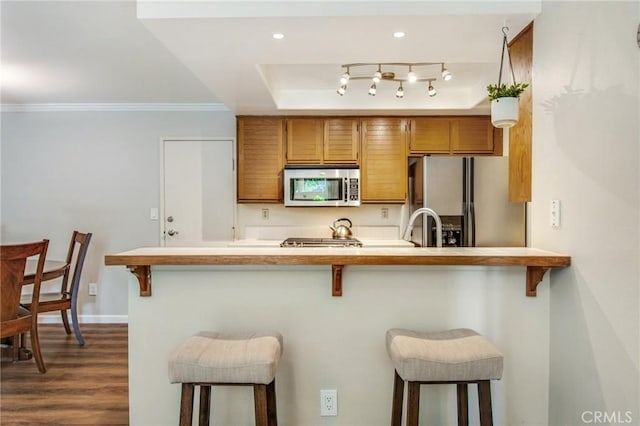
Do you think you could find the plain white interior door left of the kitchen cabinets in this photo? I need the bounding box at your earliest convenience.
[161,139,235,247]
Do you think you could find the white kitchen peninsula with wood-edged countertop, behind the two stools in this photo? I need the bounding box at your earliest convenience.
[105,247,570,425]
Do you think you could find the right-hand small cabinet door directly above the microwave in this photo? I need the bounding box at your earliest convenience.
[324,118,360,164]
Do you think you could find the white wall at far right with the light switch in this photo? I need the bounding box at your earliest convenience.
[531,1,640,426]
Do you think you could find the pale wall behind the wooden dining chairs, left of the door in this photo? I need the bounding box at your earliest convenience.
[1,111,235,321]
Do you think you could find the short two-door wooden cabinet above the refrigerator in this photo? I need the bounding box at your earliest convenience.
[409,116,502,155]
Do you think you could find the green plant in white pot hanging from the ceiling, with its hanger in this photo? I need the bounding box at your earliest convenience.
[487,27,529,128]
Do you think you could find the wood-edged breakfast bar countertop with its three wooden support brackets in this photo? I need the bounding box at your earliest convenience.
[105,247,571,297]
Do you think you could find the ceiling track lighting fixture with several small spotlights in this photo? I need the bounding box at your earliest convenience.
[336,62,452,99]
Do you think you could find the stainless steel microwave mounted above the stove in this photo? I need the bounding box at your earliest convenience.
[284,165,360,207]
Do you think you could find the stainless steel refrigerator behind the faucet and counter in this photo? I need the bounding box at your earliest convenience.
[409,156,526,247]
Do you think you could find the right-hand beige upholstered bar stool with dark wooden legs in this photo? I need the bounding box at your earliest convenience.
[386,328,503,426]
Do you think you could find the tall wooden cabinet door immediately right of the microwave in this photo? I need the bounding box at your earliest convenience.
[360,118,407,203]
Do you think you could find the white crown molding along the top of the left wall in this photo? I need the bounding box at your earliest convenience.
[0,103,229,112]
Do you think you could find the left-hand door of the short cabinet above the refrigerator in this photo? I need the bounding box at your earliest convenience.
[409,117,451,154]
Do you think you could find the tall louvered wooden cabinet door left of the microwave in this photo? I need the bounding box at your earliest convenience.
[238,117,284,203]
